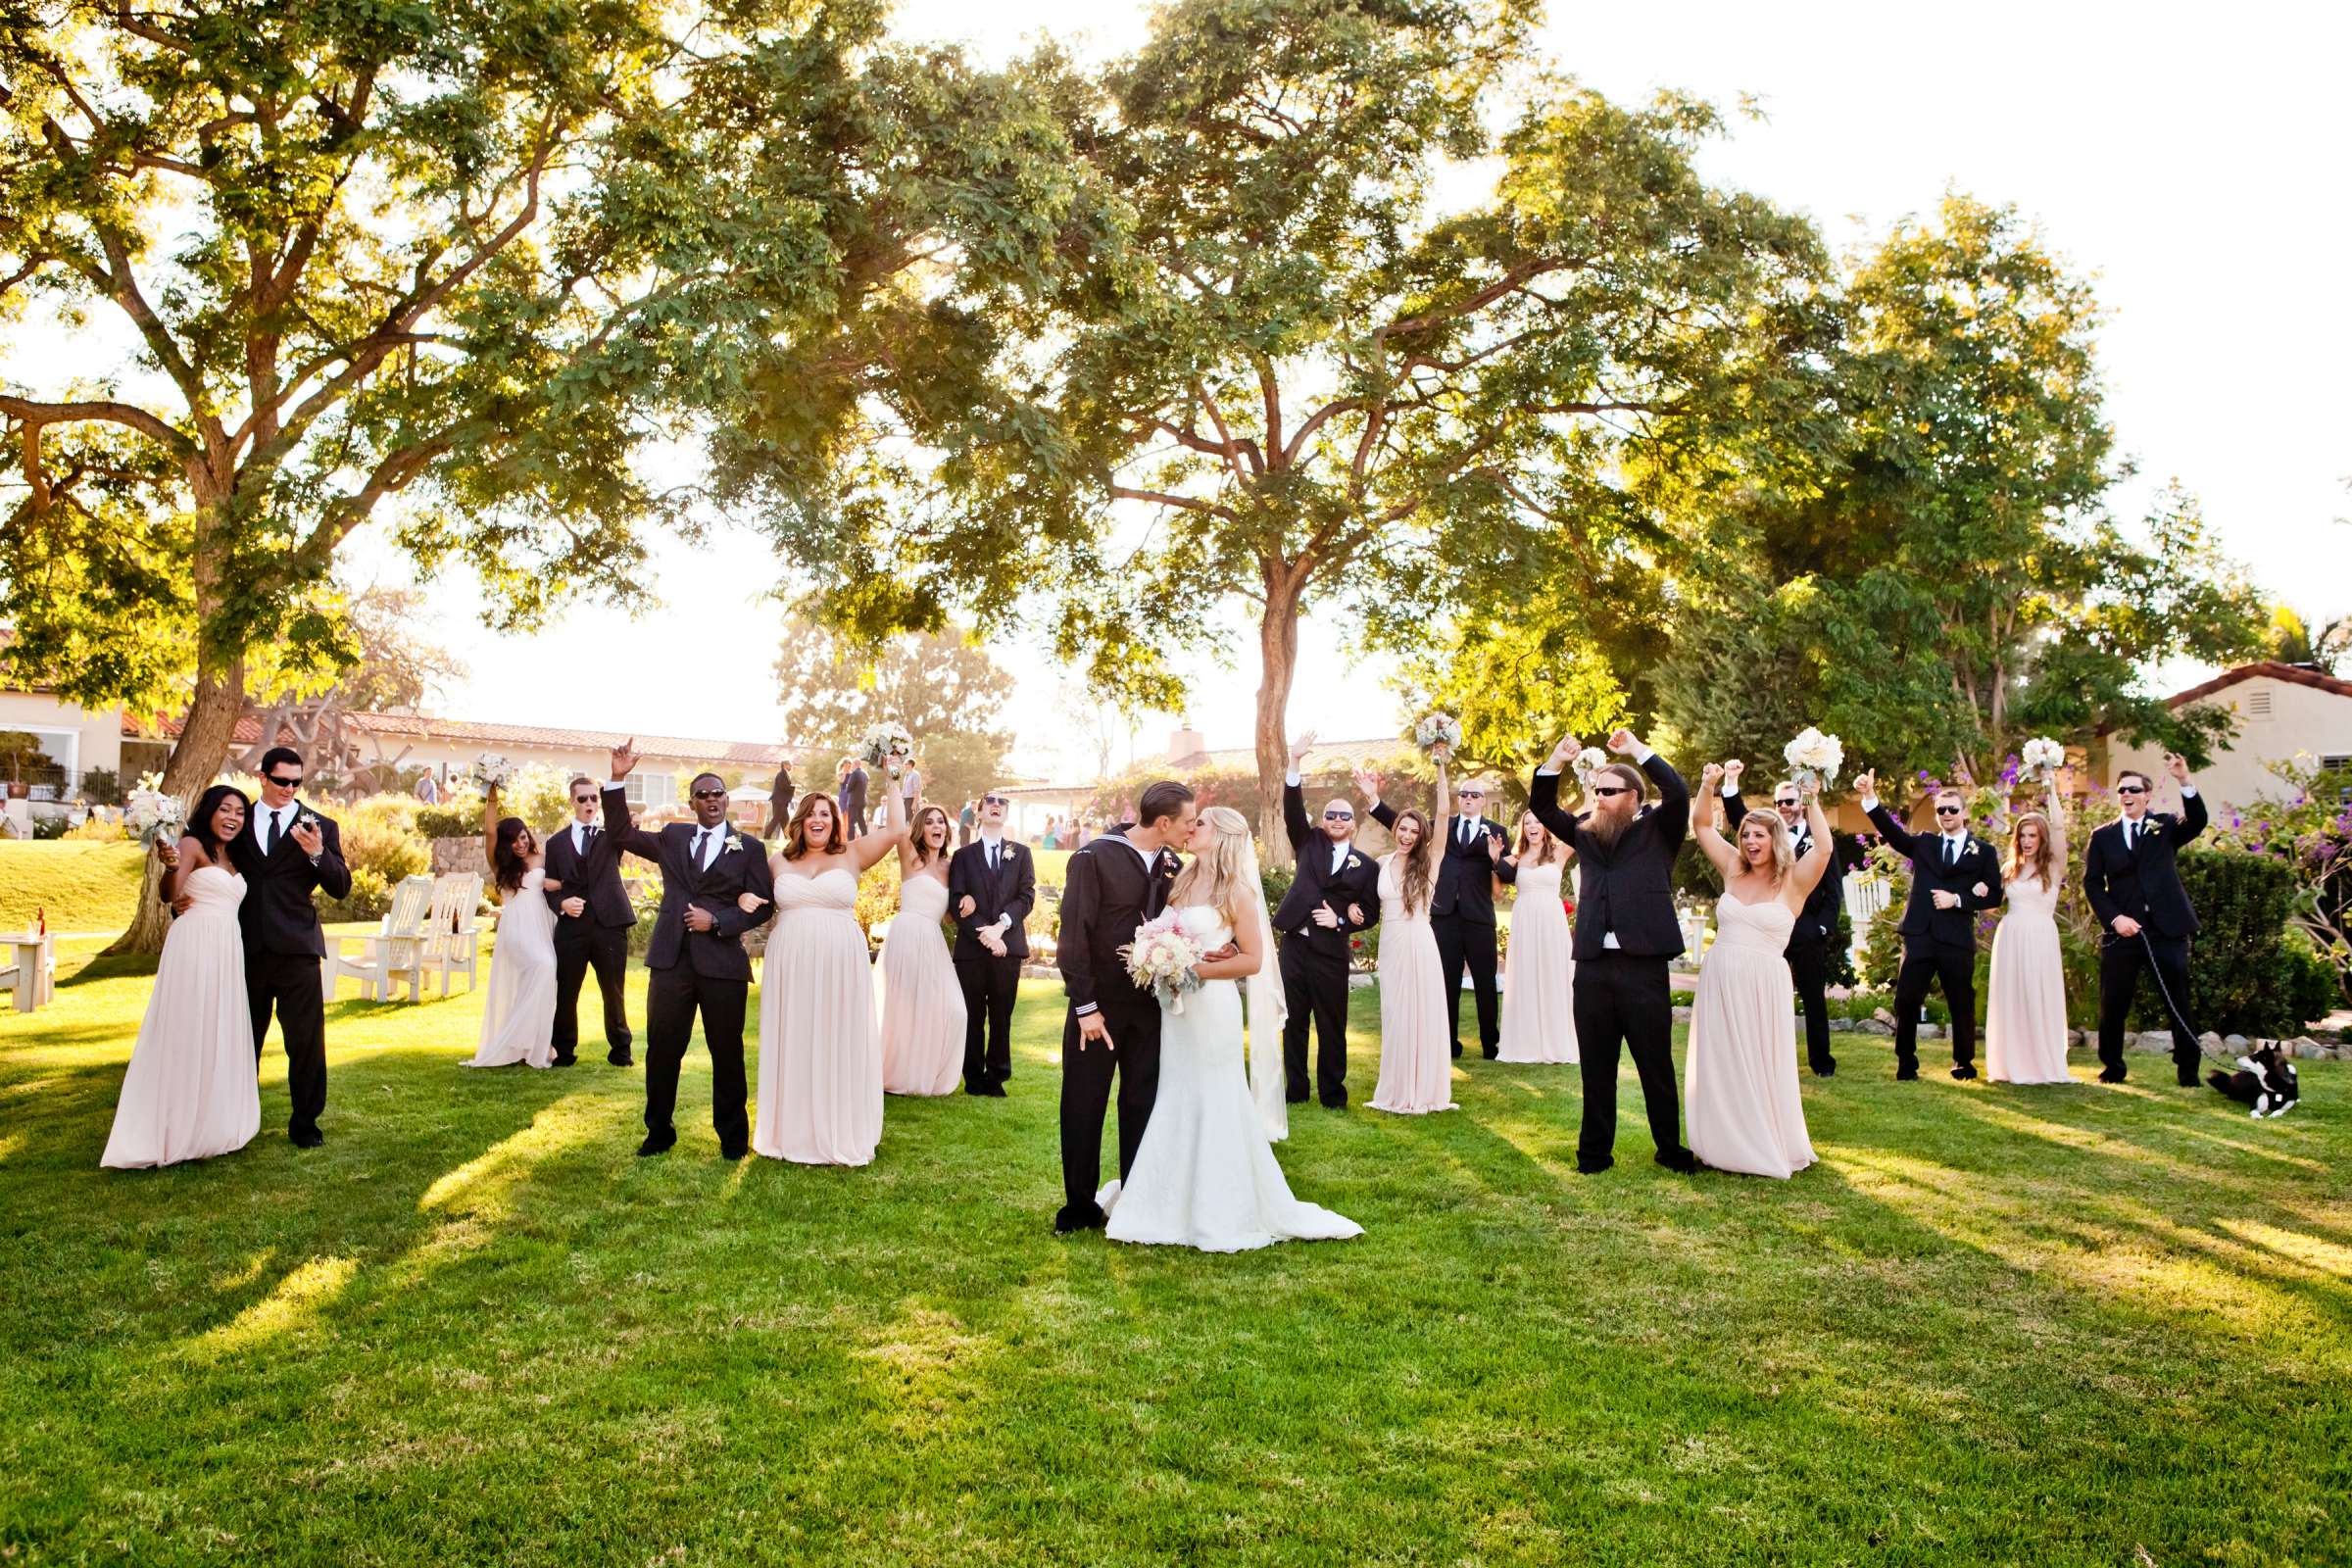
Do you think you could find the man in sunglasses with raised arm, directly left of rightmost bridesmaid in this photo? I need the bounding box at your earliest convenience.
[1853,771,2004,1081]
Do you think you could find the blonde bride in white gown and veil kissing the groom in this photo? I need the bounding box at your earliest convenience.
[1099,807,1364,1253]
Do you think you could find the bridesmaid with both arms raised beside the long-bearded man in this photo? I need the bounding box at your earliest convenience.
[1687,761,1830,1180]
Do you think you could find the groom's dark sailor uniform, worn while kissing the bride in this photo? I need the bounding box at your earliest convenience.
[1054,823,1176,1230]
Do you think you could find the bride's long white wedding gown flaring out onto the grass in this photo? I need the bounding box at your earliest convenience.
[1099,906,1364,1253]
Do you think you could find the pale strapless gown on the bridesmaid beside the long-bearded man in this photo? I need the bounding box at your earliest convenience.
[1687,894,1813,1180]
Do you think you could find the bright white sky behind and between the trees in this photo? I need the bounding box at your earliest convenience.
[341,0,2352,771]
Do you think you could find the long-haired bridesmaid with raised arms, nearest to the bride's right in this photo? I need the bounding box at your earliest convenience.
[1354,745,1453,1116]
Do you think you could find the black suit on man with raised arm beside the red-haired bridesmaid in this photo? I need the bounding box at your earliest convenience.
[605,785,776,1154]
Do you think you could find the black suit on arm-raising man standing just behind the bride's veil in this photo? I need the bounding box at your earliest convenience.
[1275,783,1381,1109]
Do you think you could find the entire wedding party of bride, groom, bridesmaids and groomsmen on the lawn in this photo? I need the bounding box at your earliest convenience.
[101,721,2206,1250]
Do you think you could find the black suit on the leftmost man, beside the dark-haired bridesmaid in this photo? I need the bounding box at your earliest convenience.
[228,802,351,1140]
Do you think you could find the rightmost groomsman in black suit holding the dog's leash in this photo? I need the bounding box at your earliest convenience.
[2082,753,2206,1089]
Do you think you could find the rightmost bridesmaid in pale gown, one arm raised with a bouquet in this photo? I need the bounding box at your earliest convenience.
[1985,780,2075,1084]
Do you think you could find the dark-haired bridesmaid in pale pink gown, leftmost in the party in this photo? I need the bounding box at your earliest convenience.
[99,785,261,1171]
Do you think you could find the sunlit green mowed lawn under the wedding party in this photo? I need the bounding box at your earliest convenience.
[0,945,2352,1568]
